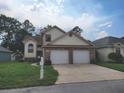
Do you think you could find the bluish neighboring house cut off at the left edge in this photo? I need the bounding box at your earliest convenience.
[0,46,12,62]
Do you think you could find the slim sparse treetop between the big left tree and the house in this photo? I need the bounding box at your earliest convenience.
[22,20,35,35]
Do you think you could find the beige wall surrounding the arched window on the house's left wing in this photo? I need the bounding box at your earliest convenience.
[24,40,37,58]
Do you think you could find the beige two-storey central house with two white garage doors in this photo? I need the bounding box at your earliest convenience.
[23,26,95,64]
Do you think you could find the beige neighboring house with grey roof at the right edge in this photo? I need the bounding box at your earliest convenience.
[92,36,124,62]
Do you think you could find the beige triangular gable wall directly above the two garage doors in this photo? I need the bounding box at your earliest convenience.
[53,34,89,45]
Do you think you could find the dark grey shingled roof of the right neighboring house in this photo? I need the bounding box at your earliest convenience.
[92,36,124,48]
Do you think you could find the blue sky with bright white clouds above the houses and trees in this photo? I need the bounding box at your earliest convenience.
[0,0,124,41]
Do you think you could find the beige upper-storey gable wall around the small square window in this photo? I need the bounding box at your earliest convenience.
[43,28,64,45]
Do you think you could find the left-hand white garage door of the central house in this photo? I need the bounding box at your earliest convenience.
[50,50,69,64]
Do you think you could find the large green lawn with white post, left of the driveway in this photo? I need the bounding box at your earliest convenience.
[0,62,58,89]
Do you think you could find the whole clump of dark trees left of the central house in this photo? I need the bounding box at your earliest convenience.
[0,15,34,53]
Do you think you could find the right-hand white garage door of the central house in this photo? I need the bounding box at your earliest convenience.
[73,50,90,64]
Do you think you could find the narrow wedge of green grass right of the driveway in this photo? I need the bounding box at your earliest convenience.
[97,63,124,72]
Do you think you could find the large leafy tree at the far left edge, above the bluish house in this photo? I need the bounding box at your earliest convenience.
[0,14,21,50]
